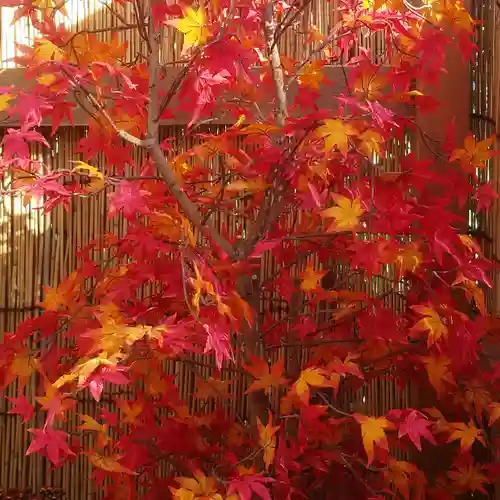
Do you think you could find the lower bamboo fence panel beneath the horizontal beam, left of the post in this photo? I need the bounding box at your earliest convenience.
[0,139,410,499]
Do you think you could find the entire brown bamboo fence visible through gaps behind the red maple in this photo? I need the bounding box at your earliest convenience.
[0,0,492,500]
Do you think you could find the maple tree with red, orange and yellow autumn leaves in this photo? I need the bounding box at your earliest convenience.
[0,0,500,500]
